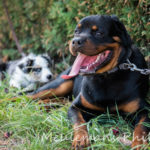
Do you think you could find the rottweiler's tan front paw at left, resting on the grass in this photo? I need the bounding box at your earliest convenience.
[72,130,90,150]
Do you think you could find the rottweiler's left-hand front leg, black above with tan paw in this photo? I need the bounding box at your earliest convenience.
[68,96,90,149]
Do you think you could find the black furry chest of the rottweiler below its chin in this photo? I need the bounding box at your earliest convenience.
[81,75,133,107]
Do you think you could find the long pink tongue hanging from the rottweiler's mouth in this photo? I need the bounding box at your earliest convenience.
[61,53,87,79]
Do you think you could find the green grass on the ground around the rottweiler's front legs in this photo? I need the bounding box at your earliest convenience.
[0,79,149,150]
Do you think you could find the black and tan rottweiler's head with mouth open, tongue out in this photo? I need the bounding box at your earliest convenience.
[62,15,132,79]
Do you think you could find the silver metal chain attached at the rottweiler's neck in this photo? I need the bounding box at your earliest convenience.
[119,59,150,75]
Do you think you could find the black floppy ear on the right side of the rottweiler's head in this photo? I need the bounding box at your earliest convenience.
[111,15,132,47]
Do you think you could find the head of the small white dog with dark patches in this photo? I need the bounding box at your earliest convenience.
[18,54,52,83]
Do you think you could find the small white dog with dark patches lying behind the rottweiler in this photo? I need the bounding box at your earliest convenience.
[0,54,52,92]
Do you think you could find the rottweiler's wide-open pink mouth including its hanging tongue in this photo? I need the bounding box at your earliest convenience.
[62,50,113,79]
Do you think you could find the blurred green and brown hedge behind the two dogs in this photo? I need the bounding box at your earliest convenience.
[0,0,150,71]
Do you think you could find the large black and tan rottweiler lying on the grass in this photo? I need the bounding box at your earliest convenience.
[30,15,150,150]
